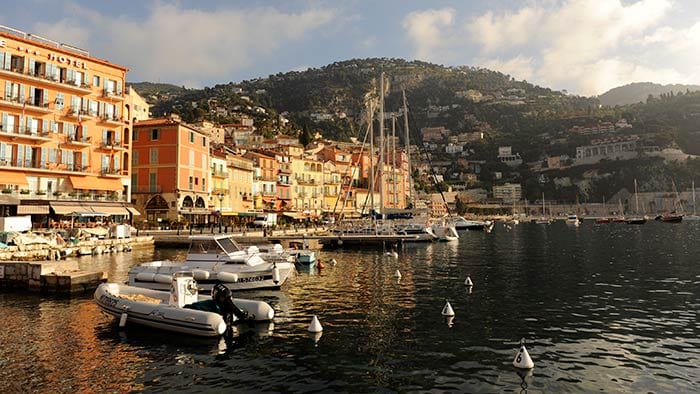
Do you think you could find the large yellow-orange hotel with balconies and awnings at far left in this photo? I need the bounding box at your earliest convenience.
[0,26,137,223]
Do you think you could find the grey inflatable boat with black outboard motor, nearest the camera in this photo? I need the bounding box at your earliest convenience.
[94,272,275,337]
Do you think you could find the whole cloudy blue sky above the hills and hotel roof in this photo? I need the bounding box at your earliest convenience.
[0,0,700,96]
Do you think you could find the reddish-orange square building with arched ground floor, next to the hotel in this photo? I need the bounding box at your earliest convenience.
[131,115,209,224]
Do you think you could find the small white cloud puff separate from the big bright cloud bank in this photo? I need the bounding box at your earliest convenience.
[403,8,455,60]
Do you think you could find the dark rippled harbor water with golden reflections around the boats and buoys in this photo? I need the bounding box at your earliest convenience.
[0,221,700,393]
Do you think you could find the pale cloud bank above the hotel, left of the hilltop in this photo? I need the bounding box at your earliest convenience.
[36,3,336,87]
